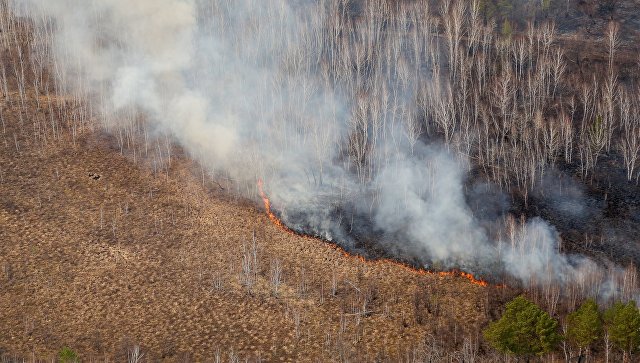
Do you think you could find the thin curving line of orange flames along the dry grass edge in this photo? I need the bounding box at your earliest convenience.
[258,179,490,287]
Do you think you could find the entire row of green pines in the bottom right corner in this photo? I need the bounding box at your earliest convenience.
[484,296,640,362]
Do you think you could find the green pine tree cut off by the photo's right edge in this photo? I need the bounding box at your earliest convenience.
[604,301,640,358]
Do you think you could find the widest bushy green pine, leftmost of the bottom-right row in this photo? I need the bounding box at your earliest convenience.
[484,296,562,359]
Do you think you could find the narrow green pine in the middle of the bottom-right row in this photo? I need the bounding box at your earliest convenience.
[567,299,602,358]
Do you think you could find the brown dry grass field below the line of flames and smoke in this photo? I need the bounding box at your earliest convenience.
[0,90,504,362]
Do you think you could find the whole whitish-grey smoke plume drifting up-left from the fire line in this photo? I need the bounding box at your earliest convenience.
[11,0,636,298]
